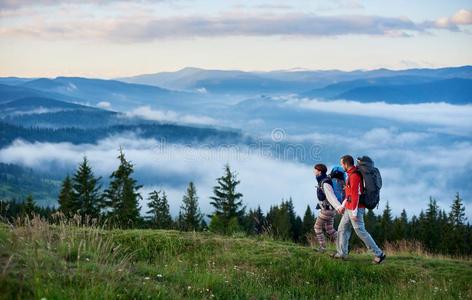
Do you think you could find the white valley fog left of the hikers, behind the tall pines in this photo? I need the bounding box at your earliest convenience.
[0,135,314,218]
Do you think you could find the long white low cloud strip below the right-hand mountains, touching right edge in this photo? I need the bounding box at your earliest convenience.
[286,98,472,134]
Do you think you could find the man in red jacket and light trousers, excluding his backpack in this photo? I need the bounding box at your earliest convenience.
[333,155,386,264]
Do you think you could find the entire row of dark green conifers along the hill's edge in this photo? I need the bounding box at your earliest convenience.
[0,149,472,255]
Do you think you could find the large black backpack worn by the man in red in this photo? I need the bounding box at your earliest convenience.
[357,156,382,209]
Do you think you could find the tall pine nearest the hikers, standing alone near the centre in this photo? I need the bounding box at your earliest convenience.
[210,165,245,227]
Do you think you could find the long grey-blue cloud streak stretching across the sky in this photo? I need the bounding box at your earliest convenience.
[0,12,466,42]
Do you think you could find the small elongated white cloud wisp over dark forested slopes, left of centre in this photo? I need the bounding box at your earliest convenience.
[125,106,220,125]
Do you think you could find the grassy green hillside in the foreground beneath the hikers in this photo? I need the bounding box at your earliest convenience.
[0,219,472,299]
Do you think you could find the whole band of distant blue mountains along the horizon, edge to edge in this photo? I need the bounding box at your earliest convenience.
[0,66,472,108]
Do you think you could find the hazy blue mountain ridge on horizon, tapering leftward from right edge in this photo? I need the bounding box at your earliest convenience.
[113,66,472,104]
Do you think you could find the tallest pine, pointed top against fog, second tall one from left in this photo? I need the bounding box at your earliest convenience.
[104,148,142,227]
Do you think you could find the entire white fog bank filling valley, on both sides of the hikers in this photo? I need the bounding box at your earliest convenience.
[0,128,472,218]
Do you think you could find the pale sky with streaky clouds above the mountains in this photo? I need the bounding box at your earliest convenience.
[0,0,472,78]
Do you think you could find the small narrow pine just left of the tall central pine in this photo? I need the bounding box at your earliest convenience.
[179,182,203,231]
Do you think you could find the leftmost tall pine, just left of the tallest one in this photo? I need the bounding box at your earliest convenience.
[72,156,102,219]
